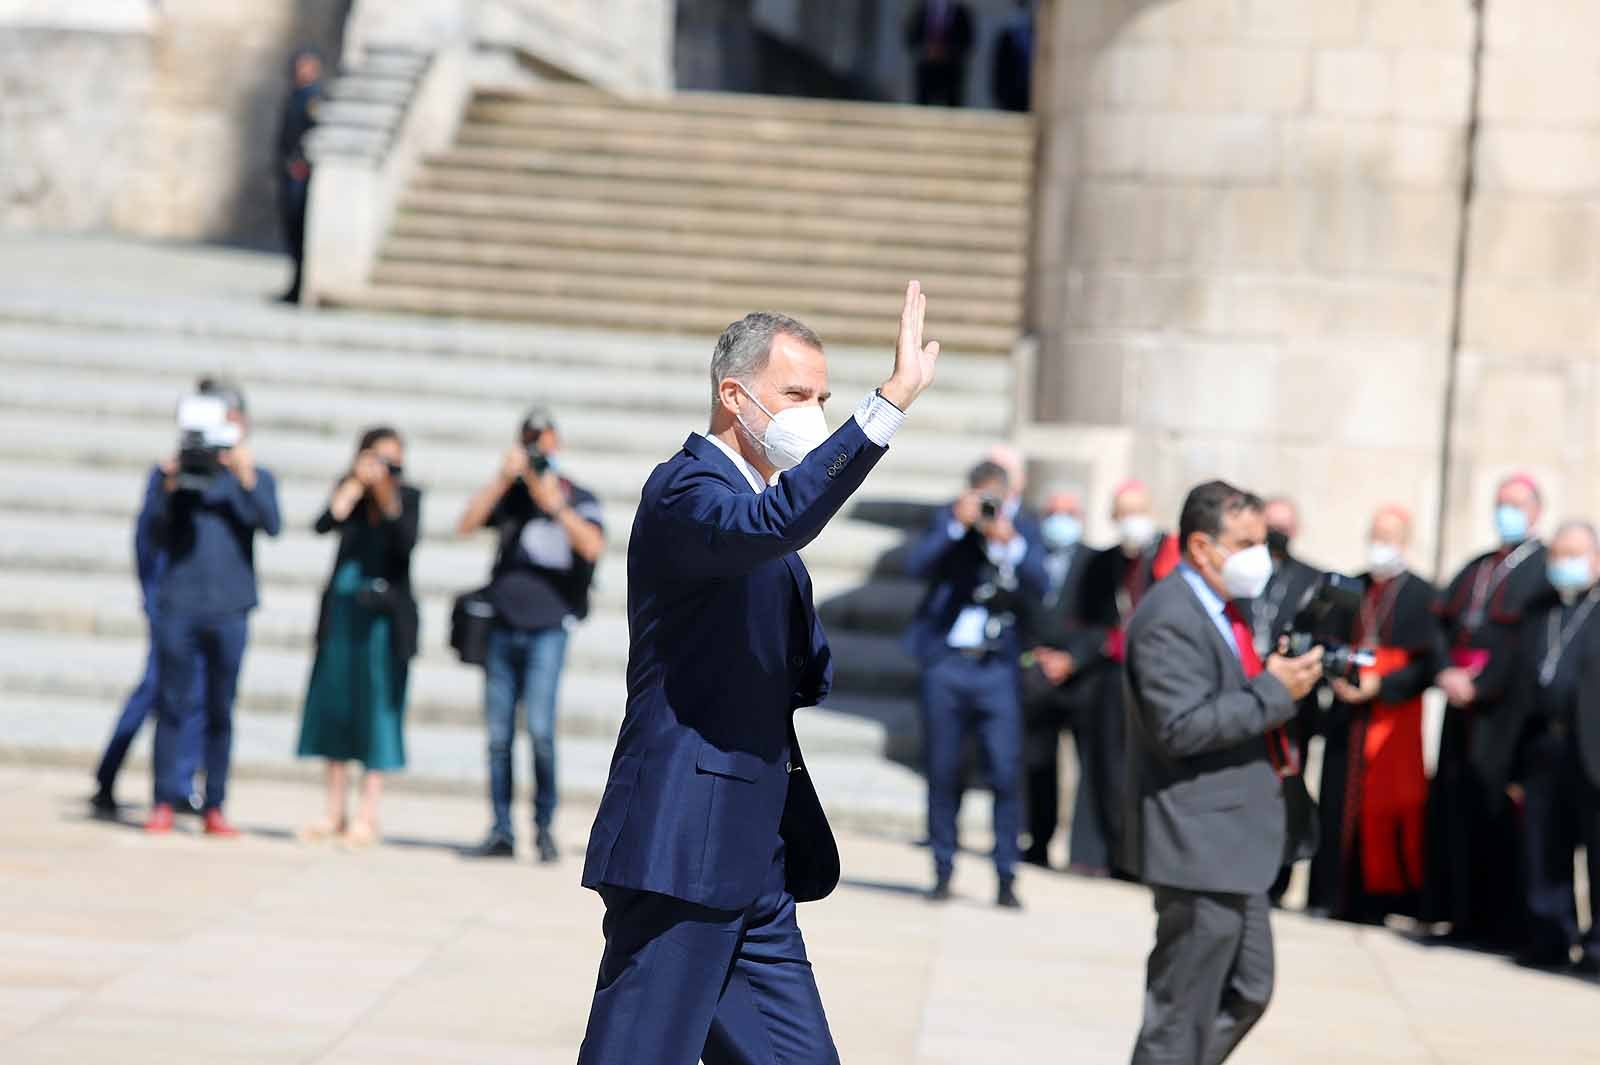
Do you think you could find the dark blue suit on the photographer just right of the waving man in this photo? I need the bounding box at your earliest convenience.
[906,507,1050,878]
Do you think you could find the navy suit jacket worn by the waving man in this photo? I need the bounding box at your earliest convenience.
[582,417,888,910]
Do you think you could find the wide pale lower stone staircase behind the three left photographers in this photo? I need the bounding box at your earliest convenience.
[0,263,1011,832]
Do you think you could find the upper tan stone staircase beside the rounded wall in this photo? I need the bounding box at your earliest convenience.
[333,88,1034,353]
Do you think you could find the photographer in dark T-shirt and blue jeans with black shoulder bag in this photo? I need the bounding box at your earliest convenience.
[458,406,605,862]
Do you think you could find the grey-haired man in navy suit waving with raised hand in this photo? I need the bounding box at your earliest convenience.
[578,281,939,1065]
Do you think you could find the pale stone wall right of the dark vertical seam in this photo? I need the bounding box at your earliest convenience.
[1445,0,1600,556]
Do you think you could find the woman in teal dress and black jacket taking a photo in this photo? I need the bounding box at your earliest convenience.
[299,427,422,848]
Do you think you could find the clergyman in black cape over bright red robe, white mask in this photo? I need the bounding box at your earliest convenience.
[1307,505,1440,923]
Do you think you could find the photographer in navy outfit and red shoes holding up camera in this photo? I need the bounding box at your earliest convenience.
[144,379,280,836]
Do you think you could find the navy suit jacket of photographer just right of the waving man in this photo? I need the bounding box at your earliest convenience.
[906,507,1050,664]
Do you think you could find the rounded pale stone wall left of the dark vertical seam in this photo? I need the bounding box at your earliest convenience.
[1030,0,1478,571]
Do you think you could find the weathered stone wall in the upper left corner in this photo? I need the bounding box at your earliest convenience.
[0,0,347,245]
